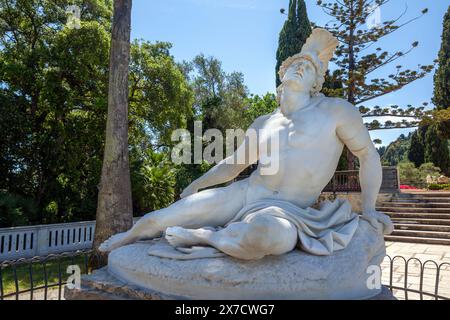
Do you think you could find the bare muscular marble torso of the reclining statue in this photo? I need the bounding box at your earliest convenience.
[247,97,344,208]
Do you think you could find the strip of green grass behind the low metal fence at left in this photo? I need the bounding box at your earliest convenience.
[0,255,86,295]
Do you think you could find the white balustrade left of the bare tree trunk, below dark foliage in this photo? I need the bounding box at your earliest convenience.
[0,221,95,261]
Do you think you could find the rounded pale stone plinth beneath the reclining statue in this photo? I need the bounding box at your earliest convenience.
[108,220,385,300]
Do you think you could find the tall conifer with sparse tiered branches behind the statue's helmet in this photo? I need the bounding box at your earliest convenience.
[317,0,434,129]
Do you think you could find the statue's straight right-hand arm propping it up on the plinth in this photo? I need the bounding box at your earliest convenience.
[337,103,393,234]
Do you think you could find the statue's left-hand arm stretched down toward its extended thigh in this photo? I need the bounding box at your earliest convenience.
[181,120,258,198]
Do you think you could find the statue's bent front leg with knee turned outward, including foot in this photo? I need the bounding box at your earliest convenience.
[166,215,298,260]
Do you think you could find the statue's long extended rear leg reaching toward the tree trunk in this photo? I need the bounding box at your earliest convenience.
[99,179,248,252]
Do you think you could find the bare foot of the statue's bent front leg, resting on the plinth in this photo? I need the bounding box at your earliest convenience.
[166,227,214,248]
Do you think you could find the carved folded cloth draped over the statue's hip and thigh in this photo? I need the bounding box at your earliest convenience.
[228,199,359,256]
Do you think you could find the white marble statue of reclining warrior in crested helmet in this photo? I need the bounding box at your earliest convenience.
[100,29,393,260]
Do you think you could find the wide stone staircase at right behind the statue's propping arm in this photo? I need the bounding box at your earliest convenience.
[377,191,450,245]
